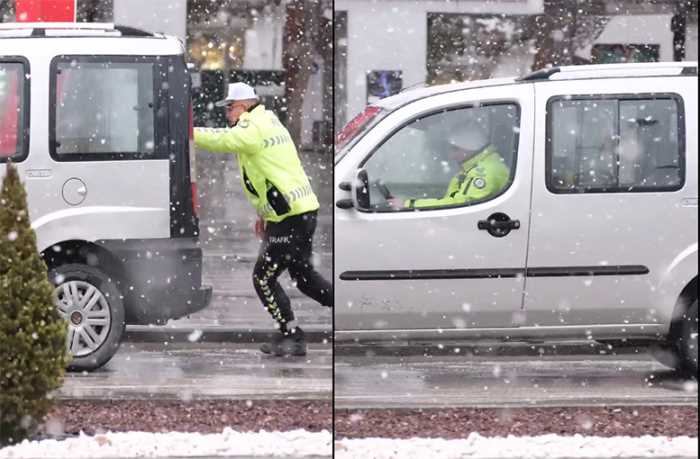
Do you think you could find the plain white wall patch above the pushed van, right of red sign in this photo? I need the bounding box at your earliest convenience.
[114,0,187,43]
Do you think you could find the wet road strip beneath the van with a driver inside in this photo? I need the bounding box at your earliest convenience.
[335,346,697,409]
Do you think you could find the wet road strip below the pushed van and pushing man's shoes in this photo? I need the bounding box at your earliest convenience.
[57,343,332,400]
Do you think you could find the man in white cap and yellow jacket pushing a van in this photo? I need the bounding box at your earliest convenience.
[194,83,333,356]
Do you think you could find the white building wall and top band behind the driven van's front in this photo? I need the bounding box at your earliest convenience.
[335,0,543,120]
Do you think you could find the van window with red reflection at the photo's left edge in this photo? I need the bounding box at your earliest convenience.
[0,62,29,162]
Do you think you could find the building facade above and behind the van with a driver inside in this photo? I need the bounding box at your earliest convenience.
[335,0,698,132]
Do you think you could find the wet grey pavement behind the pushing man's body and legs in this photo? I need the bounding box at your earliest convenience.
[126,152,333,342]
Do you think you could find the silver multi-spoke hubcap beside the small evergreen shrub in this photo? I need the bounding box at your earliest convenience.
[53,280,112,357]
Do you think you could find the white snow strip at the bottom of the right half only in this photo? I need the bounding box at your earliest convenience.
[335,433,698,459]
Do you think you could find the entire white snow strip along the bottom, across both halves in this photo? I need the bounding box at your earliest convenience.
[0,429,698,459]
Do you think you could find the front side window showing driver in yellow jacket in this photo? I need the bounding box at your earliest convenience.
[363,103,520,212]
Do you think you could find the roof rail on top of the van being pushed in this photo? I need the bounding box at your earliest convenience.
[0,22,162,37]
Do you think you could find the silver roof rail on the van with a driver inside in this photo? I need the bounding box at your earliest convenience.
[516,61,698,81]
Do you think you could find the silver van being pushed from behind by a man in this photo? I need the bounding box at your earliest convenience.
[0,23,211,369]
